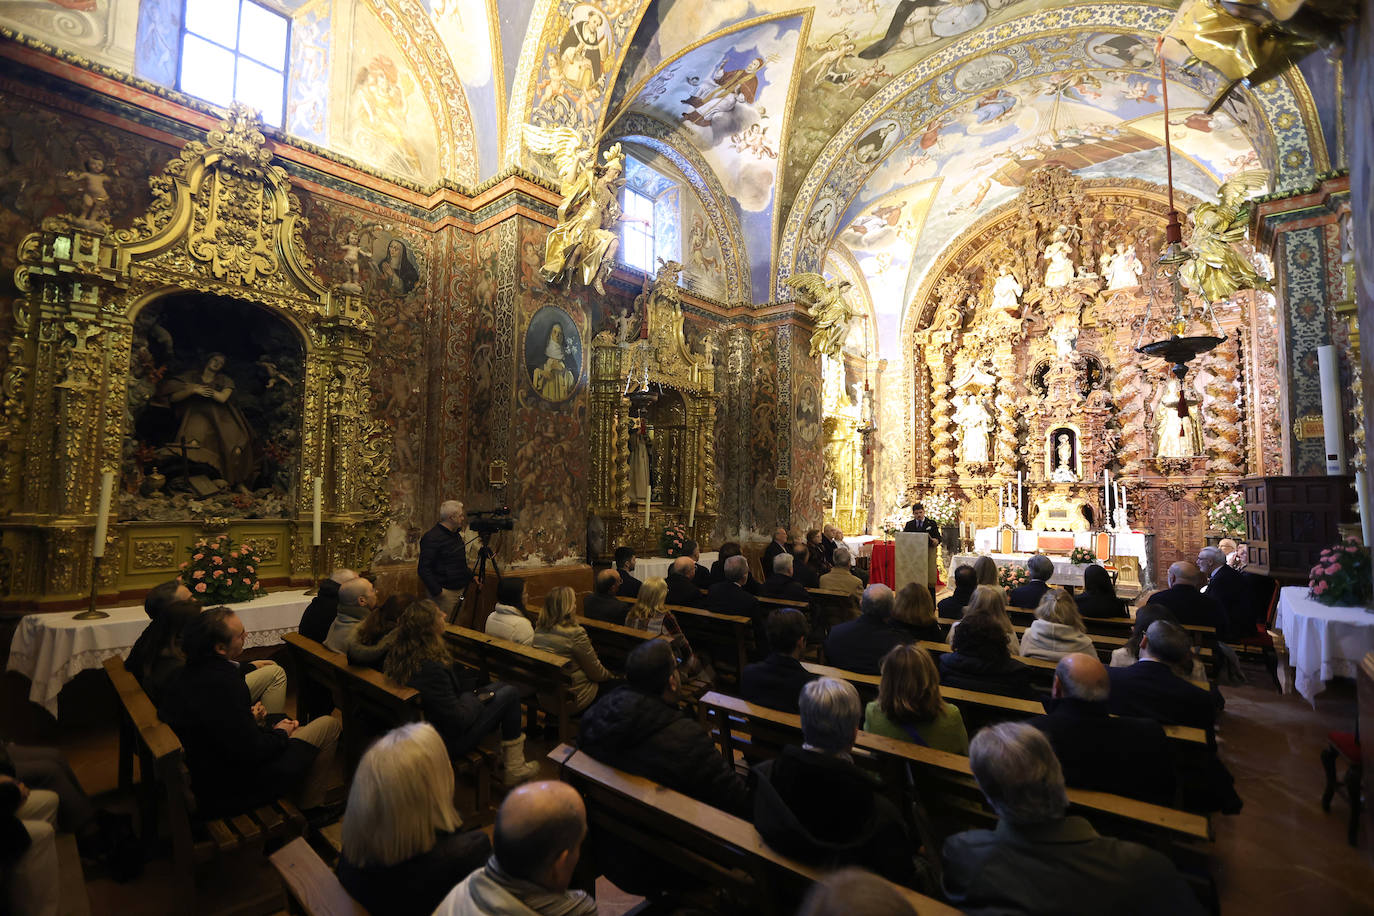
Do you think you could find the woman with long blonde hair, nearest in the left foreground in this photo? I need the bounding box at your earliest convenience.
[337,722,492,916]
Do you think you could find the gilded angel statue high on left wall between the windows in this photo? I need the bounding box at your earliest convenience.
[525,125,625,295]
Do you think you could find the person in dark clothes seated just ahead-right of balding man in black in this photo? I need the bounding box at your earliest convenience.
[1107,621,1215,735]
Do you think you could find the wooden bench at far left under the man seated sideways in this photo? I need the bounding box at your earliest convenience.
[104,655,305,913]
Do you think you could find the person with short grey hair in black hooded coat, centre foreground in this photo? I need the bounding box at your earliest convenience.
[754,677,915,884]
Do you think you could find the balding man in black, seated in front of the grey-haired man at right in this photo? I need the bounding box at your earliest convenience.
[1031,655,1176,806]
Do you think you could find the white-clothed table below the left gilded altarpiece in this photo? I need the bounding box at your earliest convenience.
[8,589,311,718]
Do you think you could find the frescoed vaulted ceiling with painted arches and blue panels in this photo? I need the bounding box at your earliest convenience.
[0,0,1334,347]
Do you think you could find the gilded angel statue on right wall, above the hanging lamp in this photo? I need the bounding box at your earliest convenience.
[1182,169,1270,304]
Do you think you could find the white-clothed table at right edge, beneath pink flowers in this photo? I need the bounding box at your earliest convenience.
[1274,585,1374,707]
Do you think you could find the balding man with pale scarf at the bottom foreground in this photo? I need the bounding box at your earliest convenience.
[434,783,596,916]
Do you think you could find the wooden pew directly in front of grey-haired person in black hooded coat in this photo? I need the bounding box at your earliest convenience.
[698,692,1212,900]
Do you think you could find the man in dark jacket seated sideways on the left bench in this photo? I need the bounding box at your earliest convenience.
[158,607,341,817]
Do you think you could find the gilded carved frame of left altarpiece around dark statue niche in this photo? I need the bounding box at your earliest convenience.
[0,107,392,604]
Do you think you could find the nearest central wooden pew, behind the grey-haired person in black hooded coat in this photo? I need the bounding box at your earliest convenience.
[548,744,958,916]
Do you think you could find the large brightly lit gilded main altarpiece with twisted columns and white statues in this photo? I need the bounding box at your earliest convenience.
[907,166,1272,581]
